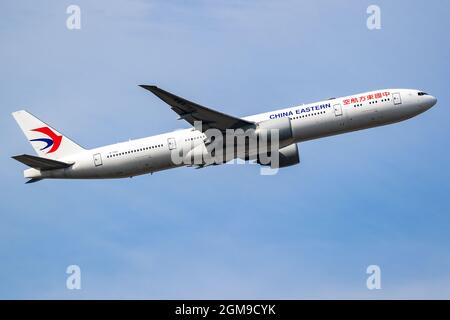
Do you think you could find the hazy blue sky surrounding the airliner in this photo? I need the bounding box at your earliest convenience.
[0,0,450,299]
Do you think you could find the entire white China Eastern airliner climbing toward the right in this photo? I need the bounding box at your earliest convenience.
[12,85,437,183]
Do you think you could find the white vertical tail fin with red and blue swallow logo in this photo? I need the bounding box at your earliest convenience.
[12,110,84,159]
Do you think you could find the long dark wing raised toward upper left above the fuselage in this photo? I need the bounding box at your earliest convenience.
[140,85,255,132]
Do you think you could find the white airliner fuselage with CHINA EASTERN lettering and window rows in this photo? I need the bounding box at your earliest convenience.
[24,89,436,179]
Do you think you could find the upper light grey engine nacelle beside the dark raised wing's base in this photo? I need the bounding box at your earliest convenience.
[256,117,294,148]
